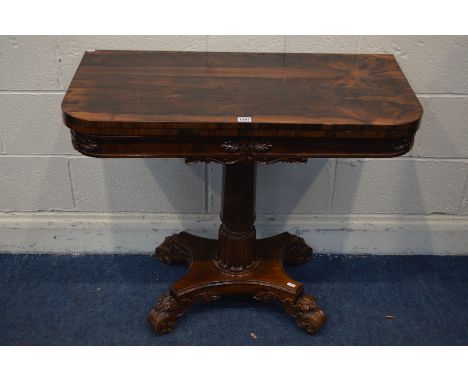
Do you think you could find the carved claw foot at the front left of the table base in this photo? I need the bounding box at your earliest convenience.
[147,295,187,334]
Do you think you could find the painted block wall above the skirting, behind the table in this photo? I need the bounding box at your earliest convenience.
[0,36,468,254]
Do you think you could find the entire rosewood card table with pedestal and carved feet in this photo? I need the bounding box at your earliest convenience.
[62,50,422,333]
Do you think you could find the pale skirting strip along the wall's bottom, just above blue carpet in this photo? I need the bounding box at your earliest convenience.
[0,212,468,255]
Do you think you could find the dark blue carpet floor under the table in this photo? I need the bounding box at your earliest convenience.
[0,255,468,345]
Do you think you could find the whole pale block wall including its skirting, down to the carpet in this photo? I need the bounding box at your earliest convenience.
[0,36,468,254]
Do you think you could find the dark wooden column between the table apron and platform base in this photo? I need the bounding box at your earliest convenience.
[215,162,256,273]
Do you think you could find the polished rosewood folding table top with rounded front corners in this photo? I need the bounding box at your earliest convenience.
[62,50,422,161]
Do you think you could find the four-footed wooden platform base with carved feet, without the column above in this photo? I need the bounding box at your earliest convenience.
[148,232,326,334]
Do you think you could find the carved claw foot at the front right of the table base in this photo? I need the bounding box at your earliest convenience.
[284,295,327,334]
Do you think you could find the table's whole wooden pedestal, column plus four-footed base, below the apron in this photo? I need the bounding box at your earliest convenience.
[148,163,326,334]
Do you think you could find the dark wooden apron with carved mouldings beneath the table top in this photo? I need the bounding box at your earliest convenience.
[68,130,414,163]
